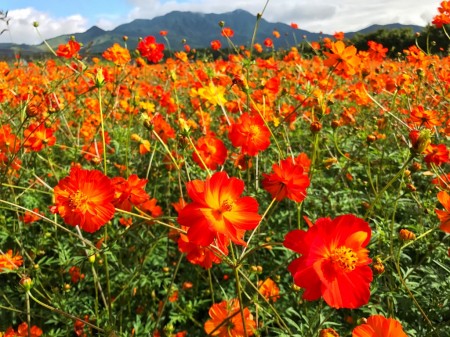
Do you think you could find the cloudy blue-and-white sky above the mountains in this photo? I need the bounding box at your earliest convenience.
[0,0,441,44]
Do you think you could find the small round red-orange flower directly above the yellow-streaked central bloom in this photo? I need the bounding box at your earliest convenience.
[192,135,227,170]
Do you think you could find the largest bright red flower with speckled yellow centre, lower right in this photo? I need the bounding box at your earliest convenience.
[284,214,372,309]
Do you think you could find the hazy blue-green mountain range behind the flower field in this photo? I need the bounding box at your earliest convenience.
[0,9,423,57]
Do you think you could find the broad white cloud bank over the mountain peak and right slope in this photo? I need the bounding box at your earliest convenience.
[128,0,441,33]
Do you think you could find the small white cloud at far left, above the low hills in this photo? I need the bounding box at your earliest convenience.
[0,7,89,44]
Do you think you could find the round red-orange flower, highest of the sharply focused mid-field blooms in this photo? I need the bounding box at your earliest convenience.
[228,113,270,156]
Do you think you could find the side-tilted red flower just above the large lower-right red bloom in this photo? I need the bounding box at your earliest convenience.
[262,158,310,202]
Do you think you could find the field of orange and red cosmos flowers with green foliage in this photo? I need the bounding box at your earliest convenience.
[0,1,450,337]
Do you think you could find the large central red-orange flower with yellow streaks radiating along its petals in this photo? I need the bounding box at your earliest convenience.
[178,172,261,247]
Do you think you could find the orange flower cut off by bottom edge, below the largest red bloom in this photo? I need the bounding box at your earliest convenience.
[352,315,407,337]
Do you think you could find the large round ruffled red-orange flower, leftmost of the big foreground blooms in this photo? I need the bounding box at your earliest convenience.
[51,166,115,233]
